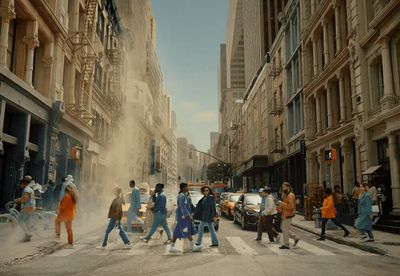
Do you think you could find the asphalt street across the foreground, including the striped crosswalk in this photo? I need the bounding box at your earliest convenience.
[0,216,400,276]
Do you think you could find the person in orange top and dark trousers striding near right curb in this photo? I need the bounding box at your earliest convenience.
[318,188,350,241]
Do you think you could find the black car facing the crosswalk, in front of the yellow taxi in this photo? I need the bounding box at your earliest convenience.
[233,194,261,229]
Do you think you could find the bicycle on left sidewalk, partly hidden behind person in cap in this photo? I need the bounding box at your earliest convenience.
[0,201,57,238]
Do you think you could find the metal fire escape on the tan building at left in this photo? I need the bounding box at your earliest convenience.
[66,0,97,127]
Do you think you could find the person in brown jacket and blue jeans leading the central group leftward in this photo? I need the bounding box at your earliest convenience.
[98,186,132,249]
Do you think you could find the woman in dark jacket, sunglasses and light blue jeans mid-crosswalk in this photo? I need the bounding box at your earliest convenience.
[193,186,219,251]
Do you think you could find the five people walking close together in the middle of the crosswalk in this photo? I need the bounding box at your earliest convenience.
[98,180,219,253]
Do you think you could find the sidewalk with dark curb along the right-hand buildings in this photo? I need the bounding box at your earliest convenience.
[292,215,400,258]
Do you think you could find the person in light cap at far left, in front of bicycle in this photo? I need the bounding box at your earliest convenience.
[15,176,36,242]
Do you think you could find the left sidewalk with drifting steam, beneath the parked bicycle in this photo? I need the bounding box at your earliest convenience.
[0,212,106,267]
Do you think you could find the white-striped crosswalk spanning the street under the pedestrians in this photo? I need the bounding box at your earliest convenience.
[49,236,374,258]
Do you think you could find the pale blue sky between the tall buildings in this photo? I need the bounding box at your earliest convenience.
[152,0,228,151]
